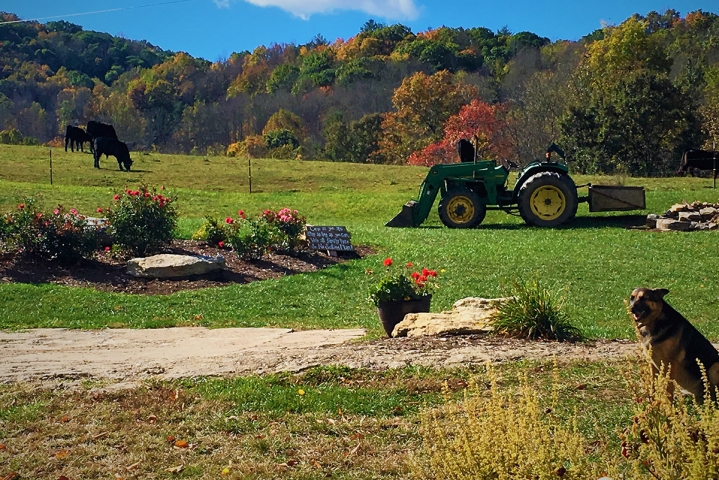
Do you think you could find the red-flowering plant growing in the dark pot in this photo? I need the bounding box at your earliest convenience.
[368,258,437,306]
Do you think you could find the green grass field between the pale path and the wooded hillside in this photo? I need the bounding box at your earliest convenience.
[0,145,719,340]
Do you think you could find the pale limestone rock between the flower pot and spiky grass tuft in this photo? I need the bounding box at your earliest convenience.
[392,297,507,337]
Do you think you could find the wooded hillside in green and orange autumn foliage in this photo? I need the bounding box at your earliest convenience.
[0,10,719,175]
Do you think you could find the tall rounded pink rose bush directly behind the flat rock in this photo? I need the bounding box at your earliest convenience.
[107,186,177,256]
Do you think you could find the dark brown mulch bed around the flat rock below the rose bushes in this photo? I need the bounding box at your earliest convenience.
[0,240,375,295]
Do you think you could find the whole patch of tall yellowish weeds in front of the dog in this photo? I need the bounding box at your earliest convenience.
[414,361,719,480]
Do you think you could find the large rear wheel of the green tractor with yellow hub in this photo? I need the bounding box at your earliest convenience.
[518,172,578,227]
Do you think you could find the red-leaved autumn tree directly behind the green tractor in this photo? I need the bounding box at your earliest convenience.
[407,99,511,166]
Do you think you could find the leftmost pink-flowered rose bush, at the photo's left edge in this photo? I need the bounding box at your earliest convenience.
[0,198,99,264]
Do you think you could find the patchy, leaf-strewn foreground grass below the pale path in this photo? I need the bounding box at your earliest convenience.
[0,362,632,479]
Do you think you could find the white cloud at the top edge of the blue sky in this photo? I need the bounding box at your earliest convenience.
[239,0,418,20]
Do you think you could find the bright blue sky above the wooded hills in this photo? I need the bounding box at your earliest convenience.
[0,0,719,61]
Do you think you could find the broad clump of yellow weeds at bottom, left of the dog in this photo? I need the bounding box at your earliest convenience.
[415,364,611,480]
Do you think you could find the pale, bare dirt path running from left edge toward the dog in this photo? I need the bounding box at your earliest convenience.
[0,327,636,381]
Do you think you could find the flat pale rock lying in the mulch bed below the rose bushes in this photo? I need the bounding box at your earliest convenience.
[127,253,225,278]
